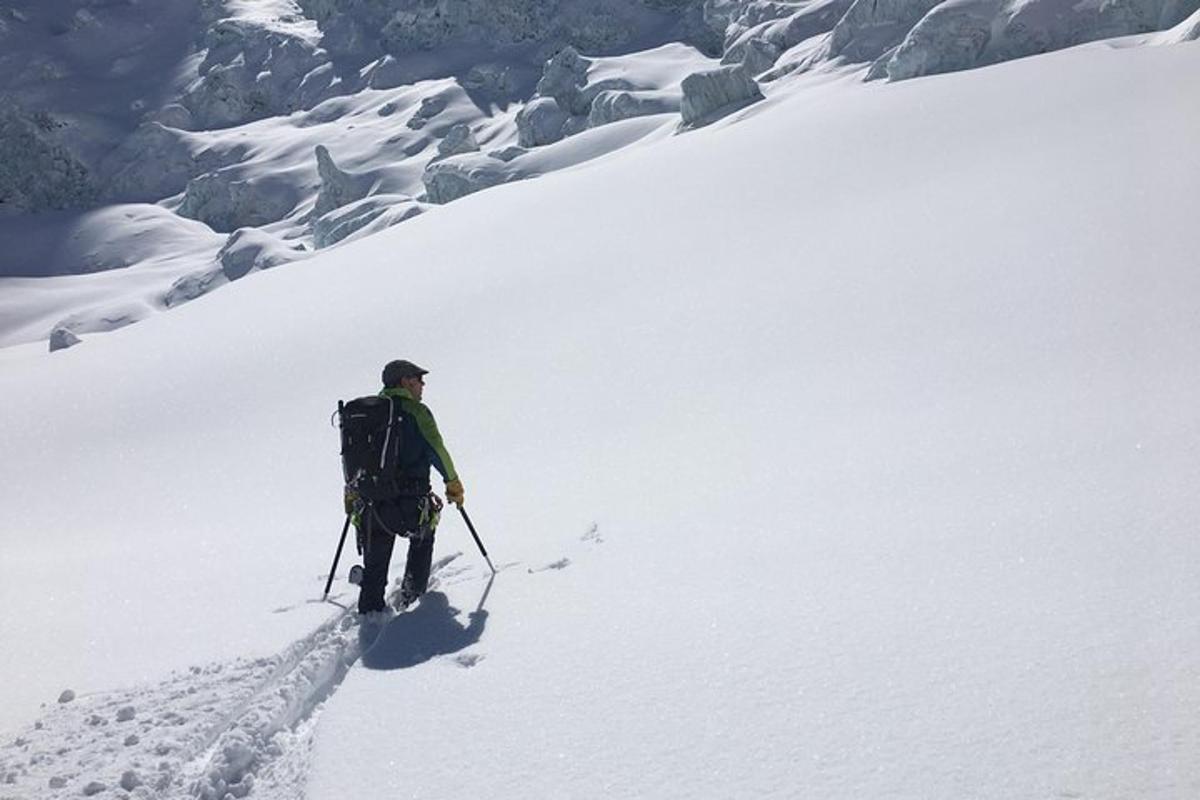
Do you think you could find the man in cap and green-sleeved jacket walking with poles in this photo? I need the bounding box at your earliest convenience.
[347,361,463,614]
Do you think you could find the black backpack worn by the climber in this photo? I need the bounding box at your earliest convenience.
[337,396,404,503]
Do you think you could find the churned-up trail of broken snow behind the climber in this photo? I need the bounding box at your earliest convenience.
[0,553,463,800]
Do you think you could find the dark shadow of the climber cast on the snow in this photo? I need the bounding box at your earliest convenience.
[362,582,491,669]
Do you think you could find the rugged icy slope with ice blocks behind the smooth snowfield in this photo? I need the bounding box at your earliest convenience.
[0,0,1200,350]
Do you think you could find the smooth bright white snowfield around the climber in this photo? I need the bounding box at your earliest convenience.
[0,37,1200,799]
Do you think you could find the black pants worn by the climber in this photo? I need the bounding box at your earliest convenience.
[359,498,433,613]
